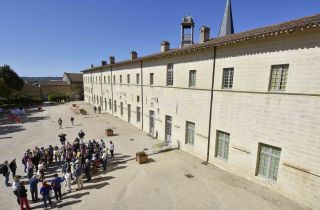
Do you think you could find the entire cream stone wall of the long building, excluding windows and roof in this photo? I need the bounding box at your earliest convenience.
[84,30,320,209]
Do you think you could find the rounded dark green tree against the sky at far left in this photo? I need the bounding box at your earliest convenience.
[0,65,24,92]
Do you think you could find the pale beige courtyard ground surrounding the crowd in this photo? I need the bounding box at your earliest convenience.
[0,102,306,210]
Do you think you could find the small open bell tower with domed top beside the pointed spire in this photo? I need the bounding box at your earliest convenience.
[180,15,194,47]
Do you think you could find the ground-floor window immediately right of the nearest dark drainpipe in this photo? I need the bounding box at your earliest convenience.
[216,131,230,160]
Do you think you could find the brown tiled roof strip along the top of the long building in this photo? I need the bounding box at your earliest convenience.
[82,14,320,72]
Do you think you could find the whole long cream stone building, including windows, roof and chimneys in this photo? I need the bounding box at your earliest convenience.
[83,14,320,209]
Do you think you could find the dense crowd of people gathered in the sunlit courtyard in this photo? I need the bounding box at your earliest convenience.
[2,126,114,210]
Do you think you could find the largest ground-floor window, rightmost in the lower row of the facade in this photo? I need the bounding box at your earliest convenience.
[257,144,281,181]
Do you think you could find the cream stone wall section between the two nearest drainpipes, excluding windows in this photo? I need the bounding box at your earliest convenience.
[143,52,213,159]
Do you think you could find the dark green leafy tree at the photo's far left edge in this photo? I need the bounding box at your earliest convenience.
[0,65,24,98]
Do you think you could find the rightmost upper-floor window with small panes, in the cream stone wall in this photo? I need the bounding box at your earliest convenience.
[270,64,289,91]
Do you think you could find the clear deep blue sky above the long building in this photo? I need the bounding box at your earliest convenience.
[0,0,320,76]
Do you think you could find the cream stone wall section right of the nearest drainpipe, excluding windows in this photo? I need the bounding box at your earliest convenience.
[210,29,320,209]
